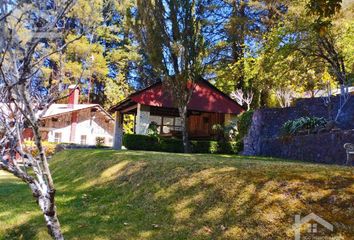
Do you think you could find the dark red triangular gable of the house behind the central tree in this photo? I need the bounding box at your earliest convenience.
[112,80,244,114]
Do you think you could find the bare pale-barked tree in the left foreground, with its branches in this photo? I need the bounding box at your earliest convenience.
[0,0,78,240]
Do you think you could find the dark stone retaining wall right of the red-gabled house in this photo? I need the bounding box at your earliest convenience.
[243,97,354,163]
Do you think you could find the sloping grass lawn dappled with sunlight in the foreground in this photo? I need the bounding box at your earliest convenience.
[0,150,354,240]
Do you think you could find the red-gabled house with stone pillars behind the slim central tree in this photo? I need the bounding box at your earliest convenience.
[110,80,244,148]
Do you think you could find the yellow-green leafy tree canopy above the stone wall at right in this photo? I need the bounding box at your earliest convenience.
[252,1,351,109]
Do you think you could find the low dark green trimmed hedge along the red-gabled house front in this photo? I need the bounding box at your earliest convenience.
[123,134,242,154]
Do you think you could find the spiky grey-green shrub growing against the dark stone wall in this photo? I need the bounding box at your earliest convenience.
[281,117,327,135]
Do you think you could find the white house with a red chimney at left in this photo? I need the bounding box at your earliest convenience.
[24,86,114,146]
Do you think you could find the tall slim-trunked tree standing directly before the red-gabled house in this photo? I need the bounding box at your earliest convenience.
[135,0,205,152]
